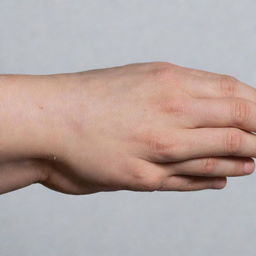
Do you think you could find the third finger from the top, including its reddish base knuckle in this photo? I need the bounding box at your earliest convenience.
[147,128,256,163]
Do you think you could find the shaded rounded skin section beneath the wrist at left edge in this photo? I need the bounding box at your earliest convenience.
[0,160,50,194]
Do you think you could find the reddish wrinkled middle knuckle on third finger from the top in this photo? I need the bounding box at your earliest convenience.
[225,129,242,155]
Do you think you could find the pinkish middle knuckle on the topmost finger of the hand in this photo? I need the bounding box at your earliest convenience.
[219,75,238,97]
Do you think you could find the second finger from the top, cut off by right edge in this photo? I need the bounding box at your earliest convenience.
[190,98,256,131]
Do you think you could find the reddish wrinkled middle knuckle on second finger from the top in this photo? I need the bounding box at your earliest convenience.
[231,100,250,126]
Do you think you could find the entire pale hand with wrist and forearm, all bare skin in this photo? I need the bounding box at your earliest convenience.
[0,62,256,194]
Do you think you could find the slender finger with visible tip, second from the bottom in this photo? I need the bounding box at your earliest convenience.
[163,157,255,177]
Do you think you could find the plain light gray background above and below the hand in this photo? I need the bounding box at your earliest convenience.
[0,0,256,256]
